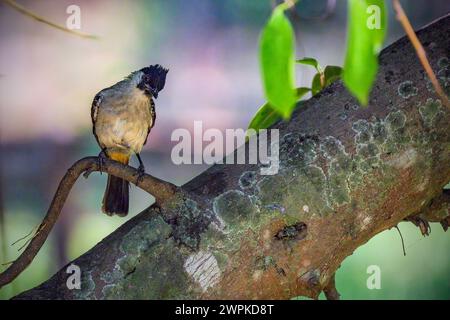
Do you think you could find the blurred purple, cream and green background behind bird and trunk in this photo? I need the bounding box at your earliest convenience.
[0,0,450,299]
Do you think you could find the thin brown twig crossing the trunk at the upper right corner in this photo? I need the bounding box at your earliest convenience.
[392,0,450,108]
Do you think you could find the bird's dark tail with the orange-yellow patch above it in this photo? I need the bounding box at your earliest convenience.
[102,152,130,217]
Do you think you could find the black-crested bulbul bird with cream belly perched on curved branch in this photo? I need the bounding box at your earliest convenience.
[91,65,168,216]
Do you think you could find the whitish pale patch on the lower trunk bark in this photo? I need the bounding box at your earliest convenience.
[184,251,221,292]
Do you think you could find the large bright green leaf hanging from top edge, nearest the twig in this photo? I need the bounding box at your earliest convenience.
[342,0,387,105]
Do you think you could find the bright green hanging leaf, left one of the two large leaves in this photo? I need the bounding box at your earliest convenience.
[259,5,297,119]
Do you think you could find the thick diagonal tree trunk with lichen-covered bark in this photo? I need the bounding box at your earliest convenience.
[12,15,450,299]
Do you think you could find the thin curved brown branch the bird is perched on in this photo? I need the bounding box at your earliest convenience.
[0,157,180,288]
